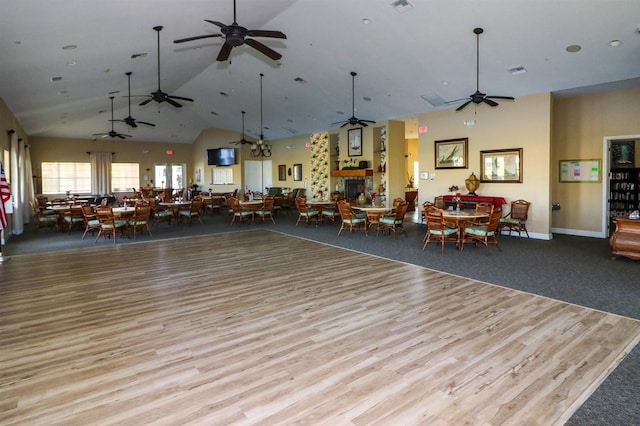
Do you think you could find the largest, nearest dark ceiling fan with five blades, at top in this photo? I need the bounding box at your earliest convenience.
[174,0,287,61]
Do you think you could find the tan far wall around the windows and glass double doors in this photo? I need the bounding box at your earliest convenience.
[29,137,193,195]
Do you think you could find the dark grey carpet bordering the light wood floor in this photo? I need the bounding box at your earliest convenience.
[3,214,640,426]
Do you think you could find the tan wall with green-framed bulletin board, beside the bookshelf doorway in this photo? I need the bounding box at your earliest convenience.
[551,89,640,235]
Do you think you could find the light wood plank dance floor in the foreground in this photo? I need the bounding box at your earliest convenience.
[0,230,640,425]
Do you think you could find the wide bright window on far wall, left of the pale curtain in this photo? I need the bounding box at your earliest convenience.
[42,162,91,194]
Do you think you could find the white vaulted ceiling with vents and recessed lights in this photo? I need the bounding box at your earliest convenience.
[0,0,640,143]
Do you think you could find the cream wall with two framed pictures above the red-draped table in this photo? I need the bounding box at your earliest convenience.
[417,93,551,239]
